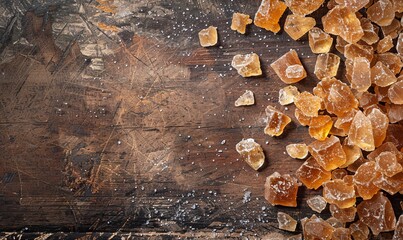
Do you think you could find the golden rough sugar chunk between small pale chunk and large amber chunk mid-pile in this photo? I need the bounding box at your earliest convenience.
[294,92,322,117]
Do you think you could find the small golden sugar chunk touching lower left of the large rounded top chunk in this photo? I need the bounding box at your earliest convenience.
[308,27,333,53]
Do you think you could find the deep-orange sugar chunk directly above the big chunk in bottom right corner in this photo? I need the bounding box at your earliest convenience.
[353,162,381,200]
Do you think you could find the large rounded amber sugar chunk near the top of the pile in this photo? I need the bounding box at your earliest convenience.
[322,5,364,43]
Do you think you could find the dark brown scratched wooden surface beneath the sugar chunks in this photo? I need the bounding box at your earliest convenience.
[0,0,402,239]
